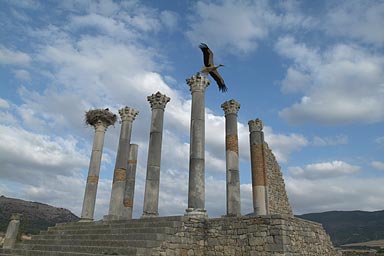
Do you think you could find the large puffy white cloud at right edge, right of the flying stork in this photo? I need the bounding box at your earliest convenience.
[276,37,384,124]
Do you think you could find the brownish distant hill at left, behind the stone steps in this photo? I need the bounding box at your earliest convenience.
[0,196,79,234]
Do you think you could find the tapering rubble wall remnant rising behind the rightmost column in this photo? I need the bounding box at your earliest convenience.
[264,143,293,216]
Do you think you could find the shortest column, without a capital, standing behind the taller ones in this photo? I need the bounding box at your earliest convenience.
[123,144,139,219]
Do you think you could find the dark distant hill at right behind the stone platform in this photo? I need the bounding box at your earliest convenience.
[296,211,384,246]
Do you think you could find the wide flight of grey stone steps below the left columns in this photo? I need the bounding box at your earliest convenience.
[0,216,183,256]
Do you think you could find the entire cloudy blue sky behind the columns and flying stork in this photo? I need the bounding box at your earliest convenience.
[0,0,384,219]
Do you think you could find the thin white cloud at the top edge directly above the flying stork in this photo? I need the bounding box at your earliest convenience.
[186,1,273,52]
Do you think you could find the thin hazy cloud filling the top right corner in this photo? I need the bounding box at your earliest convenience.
[323,1,384,46]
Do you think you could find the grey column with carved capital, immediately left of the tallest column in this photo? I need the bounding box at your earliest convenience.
[142,92,170,218]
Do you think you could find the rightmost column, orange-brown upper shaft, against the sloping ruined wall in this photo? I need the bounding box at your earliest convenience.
[248,119,268,215]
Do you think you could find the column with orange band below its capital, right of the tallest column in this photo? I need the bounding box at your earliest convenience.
[221,100,241,216]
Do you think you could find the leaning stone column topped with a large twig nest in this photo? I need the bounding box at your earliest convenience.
[80,109,117,222]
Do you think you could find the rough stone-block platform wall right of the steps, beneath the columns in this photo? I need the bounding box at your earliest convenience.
[151,215,341,256]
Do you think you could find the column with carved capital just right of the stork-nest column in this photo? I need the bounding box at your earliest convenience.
[104,107,139,220]
